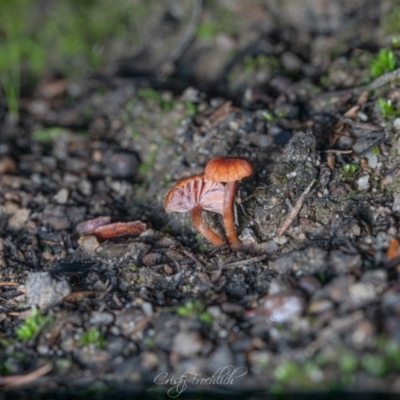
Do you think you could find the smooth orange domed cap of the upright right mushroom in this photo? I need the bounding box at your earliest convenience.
[204,157,253,182]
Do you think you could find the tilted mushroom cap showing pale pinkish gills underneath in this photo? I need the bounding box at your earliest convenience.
[164,175,225,214]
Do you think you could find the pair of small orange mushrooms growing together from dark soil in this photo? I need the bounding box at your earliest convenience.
[164,157,253,251]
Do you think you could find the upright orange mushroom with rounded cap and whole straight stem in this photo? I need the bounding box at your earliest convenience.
[204,157,253,251]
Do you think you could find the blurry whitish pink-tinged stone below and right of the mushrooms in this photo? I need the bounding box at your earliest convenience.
[259,293,305,323]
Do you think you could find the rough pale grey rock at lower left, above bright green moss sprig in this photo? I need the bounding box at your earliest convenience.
[25,272,71,310]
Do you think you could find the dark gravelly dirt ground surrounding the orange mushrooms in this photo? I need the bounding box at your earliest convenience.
[0,0,400,399]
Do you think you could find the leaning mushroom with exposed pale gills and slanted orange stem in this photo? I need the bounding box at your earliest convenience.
[164,175,225,246]
